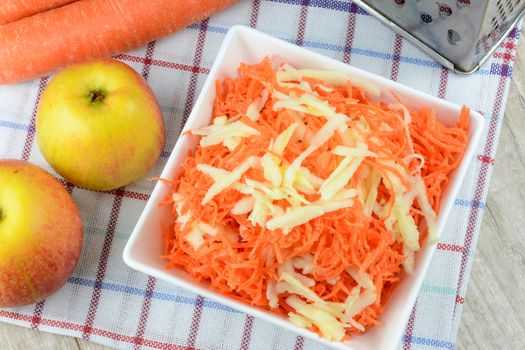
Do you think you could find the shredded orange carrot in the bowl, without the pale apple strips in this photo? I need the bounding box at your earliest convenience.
[162,59,470,340]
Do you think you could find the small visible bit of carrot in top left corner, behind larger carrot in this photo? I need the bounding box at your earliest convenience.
[0,0,76,25]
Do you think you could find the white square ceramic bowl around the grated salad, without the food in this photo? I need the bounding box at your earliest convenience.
[123,26,483,350]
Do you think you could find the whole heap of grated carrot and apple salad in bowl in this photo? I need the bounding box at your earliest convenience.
[163,58,470,340]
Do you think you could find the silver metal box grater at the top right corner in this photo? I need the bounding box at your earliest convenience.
[355,0,525,74]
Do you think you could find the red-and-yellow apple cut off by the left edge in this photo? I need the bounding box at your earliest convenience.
[0,160,83,307]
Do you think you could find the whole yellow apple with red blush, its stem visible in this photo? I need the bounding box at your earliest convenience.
[36,60,164,190]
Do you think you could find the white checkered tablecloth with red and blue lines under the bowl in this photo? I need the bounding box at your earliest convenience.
[0,0,519,350]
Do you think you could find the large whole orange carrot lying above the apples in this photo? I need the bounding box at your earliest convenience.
[0,0,236,84]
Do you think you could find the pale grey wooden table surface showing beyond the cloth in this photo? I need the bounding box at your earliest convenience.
[0,30,525,350]
